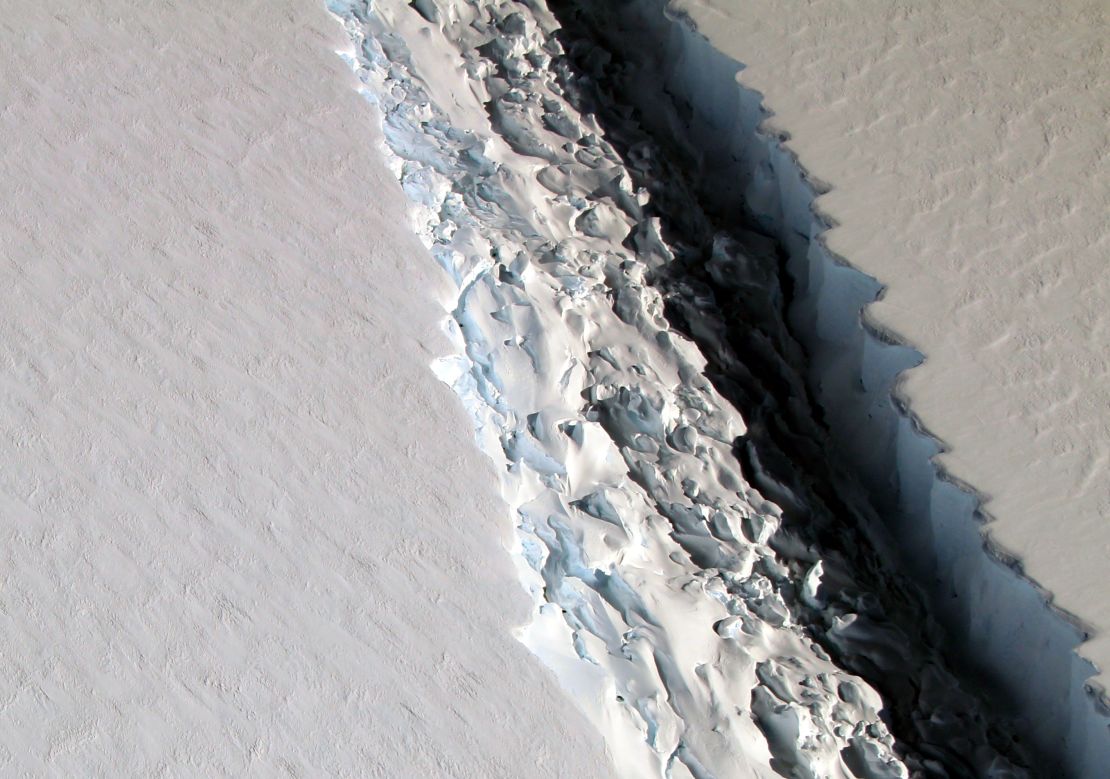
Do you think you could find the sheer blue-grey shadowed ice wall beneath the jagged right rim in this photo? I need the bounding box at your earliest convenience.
[541,0,1110,776]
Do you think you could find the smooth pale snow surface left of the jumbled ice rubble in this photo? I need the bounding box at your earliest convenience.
[0,0,612,779]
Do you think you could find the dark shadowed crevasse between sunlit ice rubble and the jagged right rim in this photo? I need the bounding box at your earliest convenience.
[549,0,1110,777]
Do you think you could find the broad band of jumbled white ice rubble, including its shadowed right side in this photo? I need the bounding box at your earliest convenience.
[329,0,1043,778]
